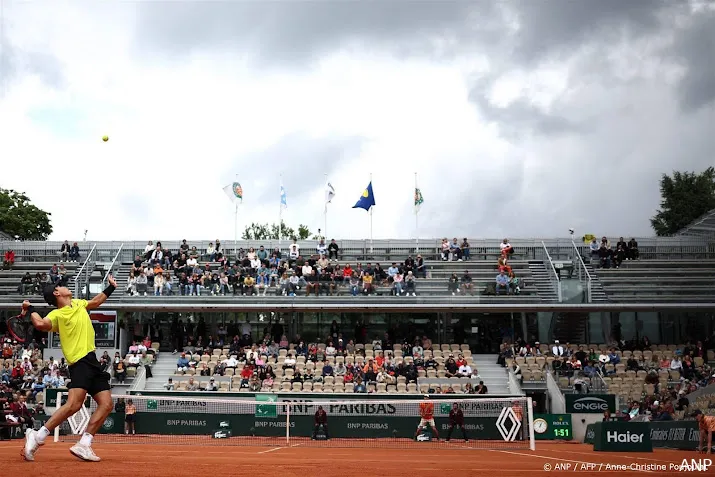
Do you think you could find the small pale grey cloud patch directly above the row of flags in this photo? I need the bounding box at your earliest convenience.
[233,132,366,207]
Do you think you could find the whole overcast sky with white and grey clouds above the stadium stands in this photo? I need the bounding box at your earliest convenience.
[0,0,715,240]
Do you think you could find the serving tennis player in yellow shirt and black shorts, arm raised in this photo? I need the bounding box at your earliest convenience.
[22,275,117,462]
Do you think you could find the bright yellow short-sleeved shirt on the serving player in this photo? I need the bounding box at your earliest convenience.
[47,300,95,364]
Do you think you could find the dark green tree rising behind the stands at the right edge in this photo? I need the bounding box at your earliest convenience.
[650,167,715,236]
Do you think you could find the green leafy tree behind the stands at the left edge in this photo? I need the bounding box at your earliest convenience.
[0,189,52,240]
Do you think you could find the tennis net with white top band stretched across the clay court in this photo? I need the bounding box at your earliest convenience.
[51,394,534,449]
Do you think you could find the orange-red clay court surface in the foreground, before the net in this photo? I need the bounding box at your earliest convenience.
[0,440,704,477]
